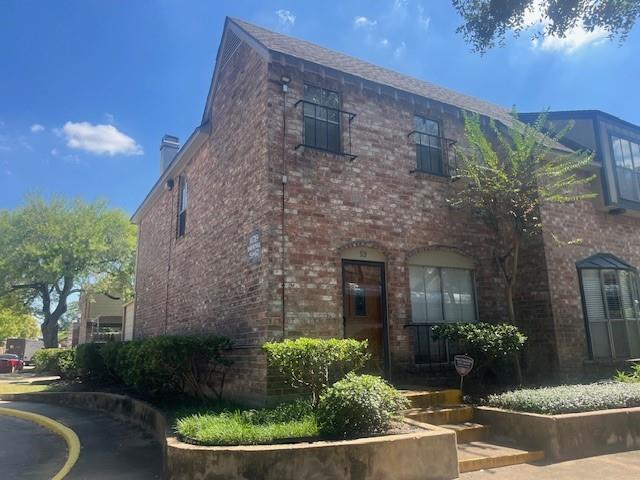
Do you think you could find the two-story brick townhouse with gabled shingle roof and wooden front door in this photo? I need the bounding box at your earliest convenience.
[133,18,640,402]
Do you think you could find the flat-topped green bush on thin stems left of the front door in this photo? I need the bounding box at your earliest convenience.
[262,338,370,407]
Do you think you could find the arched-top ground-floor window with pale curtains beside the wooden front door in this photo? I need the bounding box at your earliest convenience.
[409,250,478,324]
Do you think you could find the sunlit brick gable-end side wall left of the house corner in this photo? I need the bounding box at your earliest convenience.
[135,44,273,404]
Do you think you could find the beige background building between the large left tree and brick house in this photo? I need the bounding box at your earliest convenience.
[77,293,123,344]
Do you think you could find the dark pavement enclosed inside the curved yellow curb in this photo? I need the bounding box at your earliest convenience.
[0,415,67,480]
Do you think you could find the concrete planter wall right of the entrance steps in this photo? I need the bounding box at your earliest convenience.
[475,407,640,461]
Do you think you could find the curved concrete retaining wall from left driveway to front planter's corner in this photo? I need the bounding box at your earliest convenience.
[0,392,458,480]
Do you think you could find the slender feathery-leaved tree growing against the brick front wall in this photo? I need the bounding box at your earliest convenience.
[449,109,595,323]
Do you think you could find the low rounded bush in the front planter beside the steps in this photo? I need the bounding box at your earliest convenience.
[317,373,409,438]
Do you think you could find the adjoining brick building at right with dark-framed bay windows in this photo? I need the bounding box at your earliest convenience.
[521,110,640,370]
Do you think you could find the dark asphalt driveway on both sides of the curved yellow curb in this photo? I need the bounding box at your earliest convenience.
[0,401,162,480]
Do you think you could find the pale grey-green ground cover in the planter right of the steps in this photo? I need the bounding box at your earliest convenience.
[484,382,640,415]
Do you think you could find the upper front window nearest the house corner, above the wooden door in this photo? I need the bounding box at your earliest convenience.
[304,85,341,152]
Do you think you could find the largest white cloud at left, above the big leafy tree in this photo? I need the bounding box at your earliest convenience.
[59,122,144,156]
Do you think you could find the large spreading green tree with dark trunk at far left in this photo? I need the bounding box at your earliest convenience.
[0,196,136,348]
